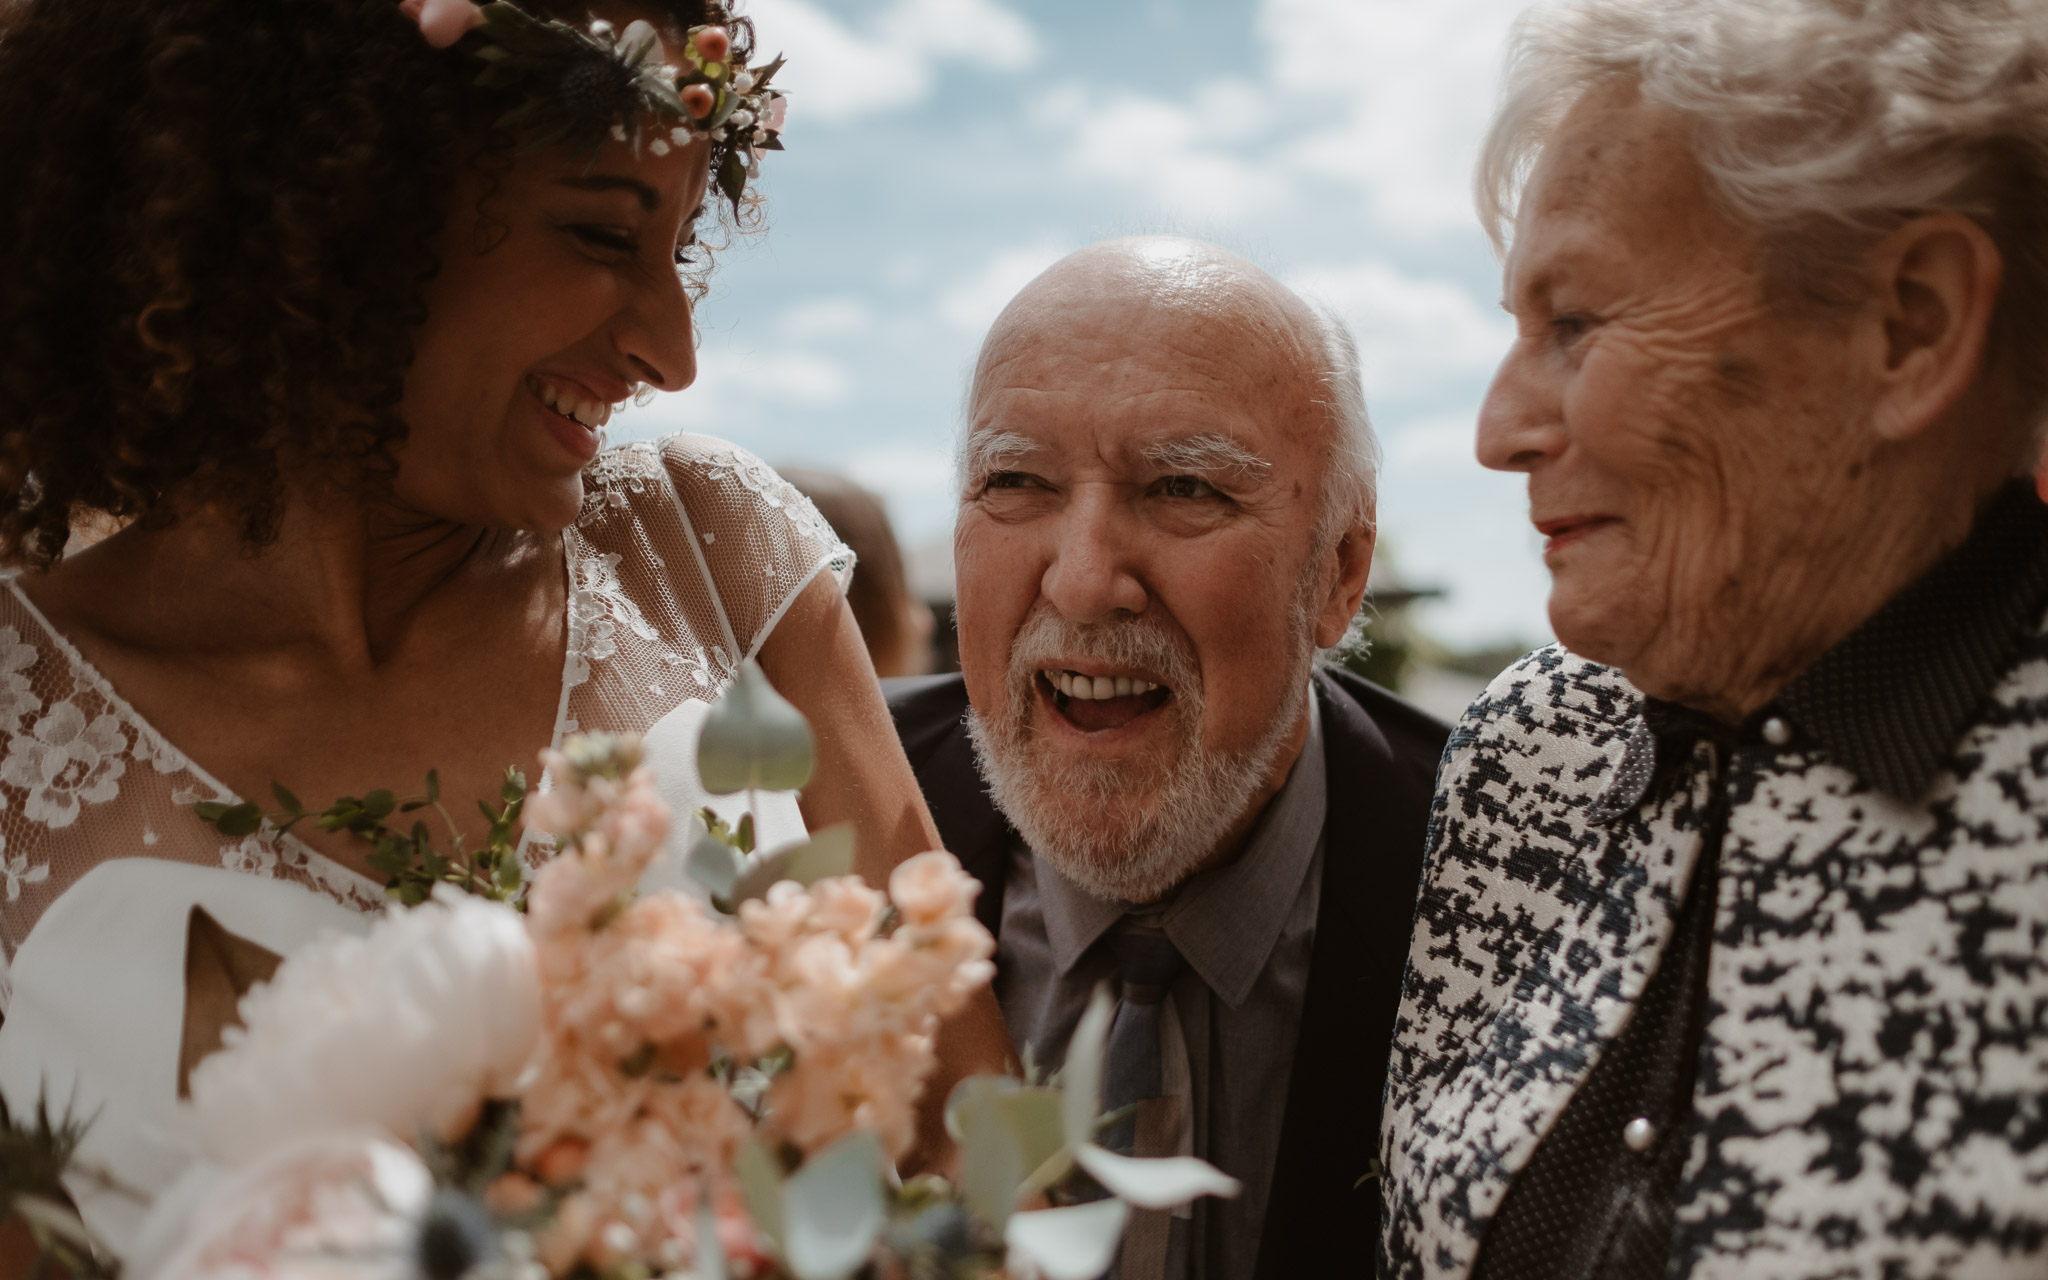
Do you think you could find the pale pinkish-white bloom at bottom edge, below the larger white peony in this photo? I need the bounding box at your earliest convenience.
[129,1128,434,1280]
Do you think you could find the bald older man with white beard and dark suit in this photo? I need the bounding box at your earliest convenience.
[891,238,1446,1280]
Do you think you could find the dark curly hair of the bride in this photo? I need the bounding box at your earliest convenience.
[0,0,752,567]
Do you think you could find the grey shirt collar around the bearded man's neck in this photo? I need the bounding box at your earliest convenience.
[1032,690,1329,1008]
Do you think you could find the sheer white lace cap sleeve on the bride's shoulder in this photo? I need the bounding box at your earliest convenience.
[662,434,854,657]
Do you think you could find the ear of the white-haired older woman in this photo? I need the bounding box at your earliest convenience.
[1858,213,2005,440]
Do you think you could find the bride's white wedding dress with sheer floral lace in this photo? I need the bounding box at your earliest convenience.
[0,436,854,1247]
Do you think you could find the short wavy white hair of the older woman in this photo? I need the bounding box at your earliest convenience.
[1477,0,2048,454]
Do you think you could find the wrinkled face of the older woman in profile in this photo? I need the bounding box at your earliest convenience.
[1479,90,1874,715]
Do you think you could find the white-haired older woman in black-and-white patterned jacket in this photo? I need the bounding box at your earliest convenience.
[1382,0,2048,1280]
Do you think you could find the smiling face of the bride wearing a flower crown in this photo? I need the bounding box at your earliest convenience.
[395,112,709,530]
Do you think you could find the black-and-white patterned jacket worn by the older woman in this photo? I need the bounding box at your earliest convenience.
[1382,625,2048,1280]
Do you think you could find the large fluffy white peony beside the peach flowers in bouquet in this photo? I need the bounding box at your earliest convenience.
[188,887,541,1165]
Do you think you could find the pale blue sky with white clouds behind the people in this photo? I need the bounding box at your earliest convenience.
[612,0,1548,645]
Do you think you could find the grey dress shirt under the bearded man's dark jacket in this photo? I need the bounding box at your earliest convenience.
[995,694,1329,1280]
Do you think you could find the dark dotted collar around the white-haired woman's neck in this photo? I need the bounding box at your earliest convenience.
[1595,481,2048,819]
